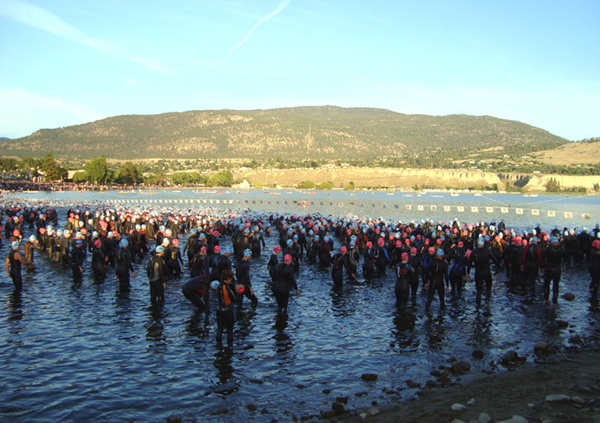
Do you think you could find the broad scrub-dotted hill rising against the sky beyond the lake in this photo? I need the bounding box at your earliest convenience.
[3,106,567,159]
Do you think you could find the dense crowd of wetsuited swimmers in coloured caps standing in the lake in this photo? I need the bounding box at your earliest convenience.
[0,207,600,345]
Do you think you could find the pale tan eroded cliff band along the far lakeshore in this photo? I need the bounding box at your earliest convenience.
[235,168,600,192]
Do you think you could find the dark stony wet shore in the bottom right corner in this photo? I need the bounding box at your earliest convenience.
[331,345,600,423]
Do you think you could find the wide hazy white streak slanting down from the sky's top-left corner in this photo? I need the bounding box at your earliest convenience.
[0,0,170,73]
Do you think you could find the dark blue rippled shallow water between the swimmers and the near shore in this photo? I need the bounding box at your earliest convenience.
[0,191,600,422]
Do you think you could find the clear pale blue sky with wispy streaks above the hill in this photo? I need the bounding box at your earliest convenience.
[0,0,600,141]
